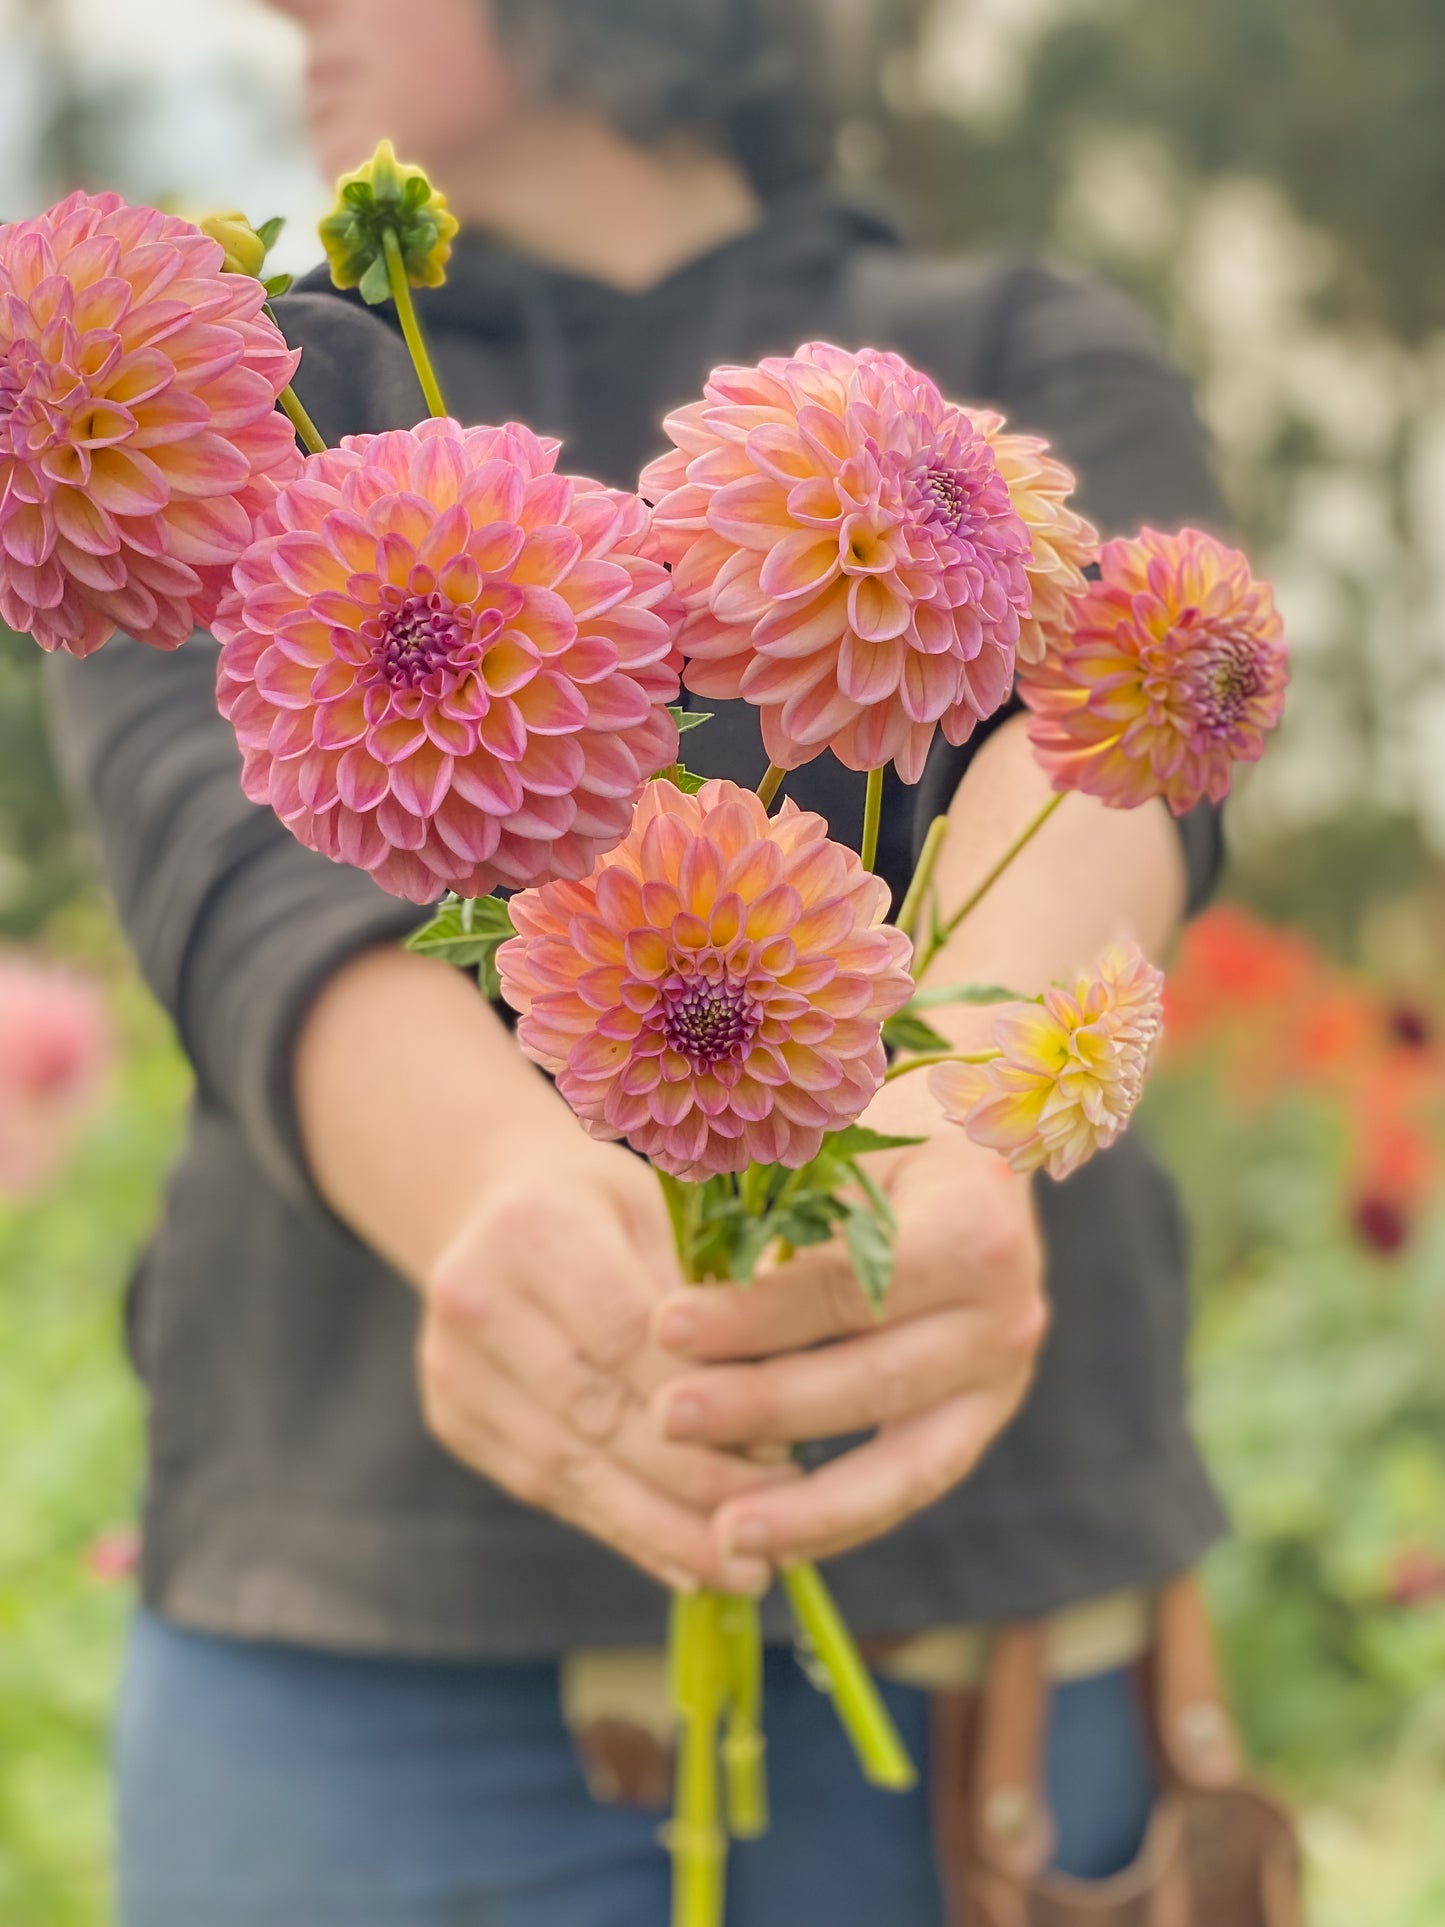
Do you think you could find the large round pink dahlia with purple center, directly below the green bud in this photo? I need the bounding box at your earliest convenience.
[214,420,678,904]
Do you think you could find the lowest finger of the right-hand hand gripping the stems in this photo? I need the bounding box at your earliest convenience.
[715,1386,1023,1565]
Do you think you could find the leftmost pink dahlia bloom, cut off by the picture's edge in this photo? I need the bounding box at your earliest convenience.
[0,193,301,655]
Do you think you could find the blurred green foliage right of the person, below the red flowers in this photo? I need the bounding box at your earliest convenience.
[1146,1071,1445,1788]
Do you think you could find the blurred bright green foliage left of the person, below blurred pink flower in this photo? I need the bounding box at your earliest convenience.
[0,963,187,1927]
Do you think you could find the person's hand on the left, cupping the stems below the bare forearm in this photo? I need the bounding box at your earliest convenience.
[418,1116,798,1592]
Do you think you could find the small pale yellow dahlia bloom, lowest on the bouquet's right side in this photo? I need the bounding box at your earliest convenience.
[929,942,1164,1177]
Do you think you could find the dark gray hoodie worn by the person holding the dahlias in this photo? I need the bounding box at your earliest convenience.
[42,195,1220,1657]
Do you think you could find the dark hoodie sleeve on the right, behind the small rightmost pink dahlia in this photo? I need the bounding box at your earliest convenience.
[913,262,1223,913]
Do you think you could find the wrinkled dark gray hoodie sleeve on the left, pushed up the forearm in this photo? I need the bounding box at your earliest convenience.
[46,295,435,1202]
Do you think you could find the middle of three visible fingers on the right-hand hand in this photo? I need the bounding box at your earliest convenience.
[653,1307,1019,1445]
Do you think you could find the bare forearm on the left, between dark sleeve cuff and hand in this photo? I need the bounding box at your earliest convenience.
[297,948,578,1281]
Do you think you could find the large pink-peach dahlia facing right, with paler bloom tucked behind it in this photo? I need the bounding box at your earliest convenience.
[642,341,1031,782]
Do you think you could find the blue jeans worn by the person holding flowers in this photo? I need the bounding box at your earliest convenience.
[118,1613,1150,1927]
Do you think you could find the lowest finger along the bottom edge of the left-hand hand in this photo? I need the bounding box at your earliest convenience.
[420,1333,771,1594]
